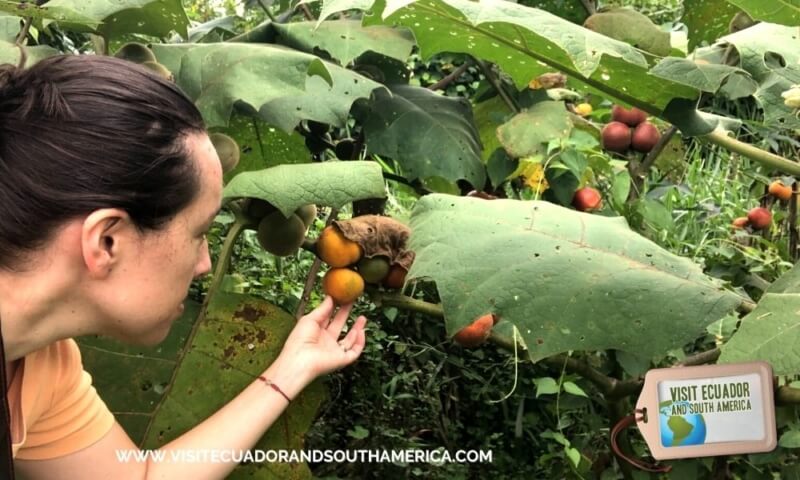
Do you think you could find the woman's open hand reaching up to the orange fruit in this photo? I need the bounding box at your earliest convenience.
[276,296,367,381]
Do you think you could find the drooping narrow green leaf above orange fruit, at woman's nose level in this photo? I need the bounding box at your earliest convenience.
[222,161,386,217]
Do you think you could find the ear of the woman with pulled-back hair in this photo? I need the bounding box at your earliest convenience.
[81,208,135,278]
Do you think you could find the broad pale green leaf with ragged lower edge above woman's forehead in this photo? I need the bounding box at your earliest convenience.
[153,42,381,132]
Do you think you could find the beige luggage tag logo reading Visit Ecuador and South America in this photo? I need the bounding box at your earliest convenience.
[636,362,777,460]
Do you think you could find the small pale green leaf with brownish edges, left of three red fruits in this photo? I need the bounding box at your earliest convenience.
[497,101,572,158]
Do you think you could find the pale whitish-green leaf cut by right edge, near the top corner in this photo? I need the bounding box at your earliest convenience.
[721,23,800,128]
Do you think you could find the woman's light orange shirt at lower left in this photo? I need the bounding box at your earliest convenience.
[8,338,114,460]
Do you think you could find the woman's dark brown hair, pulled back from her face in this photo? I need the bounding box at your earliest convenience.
[0,55,205,270]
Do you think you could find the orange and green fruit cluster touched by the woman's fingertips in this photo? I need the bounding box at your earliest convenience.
[317,225,408,305]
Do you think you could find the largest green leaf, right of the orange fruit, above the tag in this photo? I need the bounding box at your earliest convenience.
[407,194,743,361]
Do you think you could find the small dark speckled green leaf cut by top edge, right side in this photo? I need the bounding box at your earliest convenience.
[683,0,739,50]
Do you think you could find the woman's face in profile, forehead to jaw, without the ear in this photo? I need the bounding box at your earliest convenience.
[105,134,222,345]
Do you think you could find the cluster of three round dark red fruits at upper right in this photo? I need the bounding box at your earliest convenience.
[602,105,661,153]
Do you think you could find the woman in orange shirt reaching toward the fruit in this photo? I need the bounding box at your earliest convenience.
[0,56,366,480]
